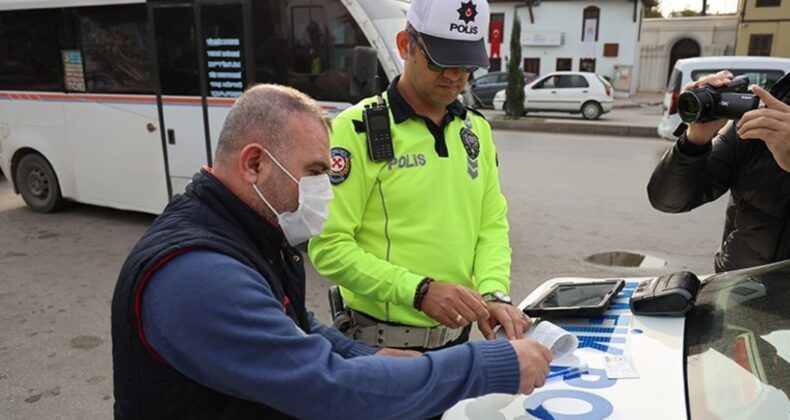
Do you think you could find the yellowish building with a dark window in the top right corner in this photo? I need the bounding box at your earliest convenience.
[735,0,790,58]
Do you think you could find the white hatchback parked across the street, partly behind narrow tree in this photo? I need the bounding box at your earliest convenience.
[494,71,614,120]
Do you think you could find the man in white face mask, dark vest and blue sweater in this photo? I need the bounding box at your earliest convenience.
[112,85,551,419]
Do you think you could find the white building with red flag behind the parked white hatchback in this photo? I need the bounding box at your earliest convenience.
[487,0,655,95]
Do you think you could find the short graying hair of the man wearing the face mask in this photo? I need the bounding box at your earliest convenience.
[214,84,327,163]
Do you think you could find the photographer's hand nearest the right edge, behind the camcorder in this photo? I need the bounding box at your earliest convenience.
[738,85,790,172]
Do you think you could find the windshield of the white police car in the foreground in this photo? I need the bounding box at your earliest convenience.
[685,260,790,420]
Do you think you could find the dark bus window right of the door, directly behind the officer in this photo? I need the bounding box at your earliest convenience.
[251,0,378,102]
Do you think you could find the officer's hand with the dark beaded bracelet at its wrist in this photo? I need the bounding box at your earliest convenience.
[420,281,490,328]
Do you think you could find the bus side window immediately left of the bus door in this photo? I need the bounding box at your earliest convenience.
[76,5,154,93]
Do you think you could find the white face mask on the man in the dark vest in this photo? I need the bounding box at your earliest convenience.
[252,149,332,246]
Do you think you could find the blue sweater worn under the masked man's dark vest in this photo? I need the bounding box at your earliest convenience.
[142,251,519,419]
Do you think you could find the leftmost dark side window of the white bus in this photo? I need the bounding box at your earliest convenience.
[0,10,63,91]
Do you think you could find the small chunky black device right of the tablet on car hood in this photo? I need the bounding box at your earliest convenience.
[631,271,700,316]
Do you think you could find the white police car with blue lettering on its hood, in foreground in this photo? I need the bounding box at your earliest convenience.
[444,260,790,420]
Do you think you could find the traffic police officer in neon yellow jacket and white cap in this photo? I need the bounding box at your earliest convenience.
[309,0,529,350]
